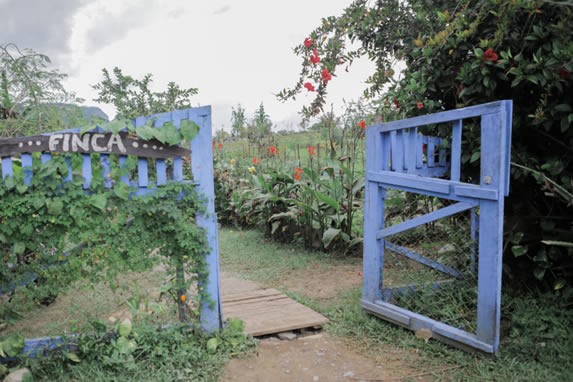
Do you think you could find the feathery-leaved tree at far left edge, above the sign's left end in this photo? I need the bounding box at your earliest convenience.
[0,43,81,137]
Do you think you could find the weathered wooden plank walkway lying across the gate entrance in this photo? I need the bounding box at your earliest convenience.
[222,289,328,336]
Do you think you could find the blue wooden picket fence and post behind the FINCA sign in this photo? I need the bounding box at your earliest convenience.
[1,106,223,352]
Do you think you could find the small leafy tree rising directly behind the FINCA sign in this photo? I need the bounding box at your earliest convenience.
[92,67,198,118]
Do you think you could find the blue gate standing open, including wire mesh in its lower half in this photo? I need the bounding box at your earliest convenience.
[362,100,512,353]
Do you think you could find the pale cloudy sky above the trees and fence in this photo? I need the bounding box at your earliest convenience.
[0,0,373,131]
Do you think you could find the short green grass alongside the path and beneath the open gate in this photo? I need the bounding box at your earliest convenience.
[219,229,573,381]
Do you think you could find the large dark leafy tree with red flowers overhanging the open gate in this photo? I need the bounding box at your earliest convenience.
[279,0,573,290]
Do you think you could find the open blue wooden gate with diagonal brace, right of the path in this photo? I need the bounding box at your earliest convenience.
[362,101,512,353]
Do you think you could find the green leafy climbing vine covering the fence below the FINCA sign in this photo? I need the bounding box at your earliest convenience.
[0,155,208,317]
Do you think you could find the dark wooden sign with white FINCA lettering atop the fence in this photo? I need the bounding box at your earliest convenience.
[0,133,190,159]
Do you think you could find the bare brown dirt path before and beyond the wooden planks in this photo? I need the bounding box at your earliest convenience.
[222,265,430,382]
